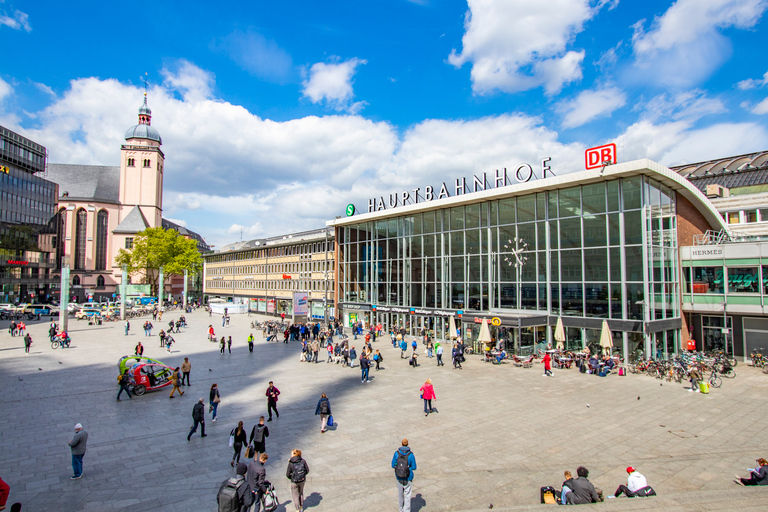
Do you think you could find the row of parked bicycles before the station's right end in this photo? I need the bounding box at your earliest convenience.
[627,352,736,388]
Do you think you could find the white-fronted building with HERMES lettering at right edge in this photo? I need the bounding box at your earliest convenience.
[673,151,768,358]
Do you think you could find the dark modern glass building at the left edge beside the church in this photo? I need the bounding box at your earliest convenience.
[0,126,58,303]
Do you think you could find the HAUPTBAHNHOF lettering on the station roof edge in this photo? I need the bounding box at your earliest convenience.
[368,157,555,213]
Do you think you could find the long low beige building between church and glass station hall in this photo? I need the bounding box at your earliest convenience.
[203,228,335,320]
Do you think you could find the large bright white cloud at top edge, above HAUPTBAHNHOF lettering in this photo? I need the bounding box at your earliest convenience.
[448,0,617,94]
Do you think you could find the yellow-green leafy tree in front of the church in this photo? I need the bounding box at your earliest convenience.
[115,228,203,296]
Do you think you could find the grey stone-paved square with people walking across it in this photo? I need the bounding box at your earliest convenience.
[0,311,768,512]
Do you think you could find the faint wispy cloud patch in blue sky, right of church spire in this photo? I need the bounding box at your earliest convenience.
[212,30,296,83]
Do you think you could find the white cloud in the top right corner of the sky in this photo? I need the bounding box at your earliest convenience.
[632,0,768,87]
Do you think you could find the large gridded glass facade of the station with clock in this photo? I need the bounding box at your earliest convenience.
[337,176,680,358]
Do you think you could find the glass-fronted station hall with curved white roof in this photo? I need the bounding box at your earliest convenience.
[328,160,725,359]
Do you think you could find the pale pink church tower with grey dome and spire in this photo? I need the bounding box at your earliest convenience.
[119,90,165,228]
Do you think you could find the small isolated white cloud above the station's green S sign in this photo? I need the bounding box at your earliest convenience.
[302,57,367,113]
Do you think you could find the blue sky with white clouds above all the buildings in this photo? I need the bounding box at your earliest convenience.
[0,0,768,247]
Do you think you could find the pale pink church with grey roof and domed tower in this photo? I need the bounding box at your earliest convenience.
[48,93,208,301]
